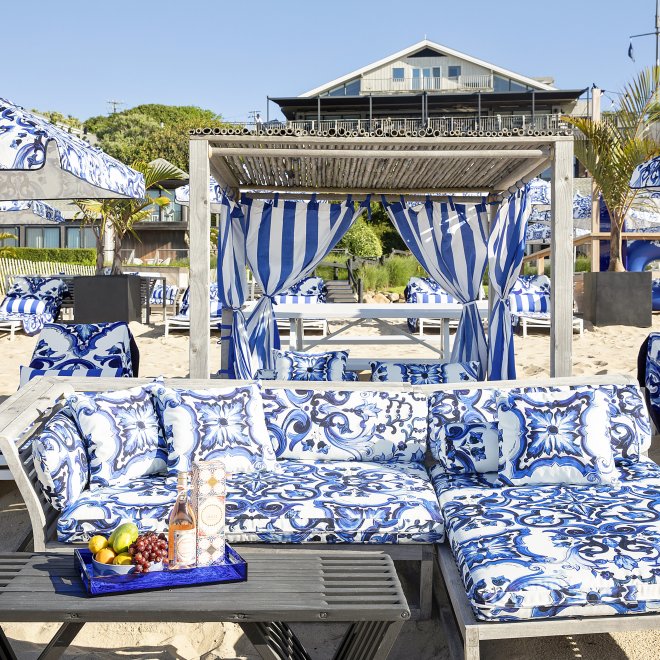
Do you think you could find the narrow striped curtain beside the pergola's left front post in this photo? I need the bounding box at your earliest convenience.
[218,195,253,380]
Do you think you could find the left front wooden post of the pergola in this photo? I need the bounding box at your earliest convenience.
[189,139,211,379]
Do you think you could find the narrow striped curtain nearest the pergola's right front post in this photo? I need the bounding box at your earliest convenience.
[488,185,531,380]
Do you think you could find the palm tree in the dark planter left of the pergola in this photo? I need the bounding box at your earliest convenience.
[76,160,184,275]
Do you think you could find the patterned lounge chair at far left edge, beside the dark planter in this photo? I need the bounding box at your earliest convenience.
[0,275,67,339]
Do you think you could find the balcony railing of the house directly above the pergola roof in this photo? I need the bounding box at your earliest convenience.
[278,114,571,136]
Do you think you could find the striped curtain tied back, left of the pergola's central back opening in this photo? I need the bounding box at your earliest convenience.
[243,197,364,369]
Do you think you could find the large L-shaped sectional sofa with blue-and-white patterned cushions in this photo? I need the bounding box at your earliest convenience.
[0,376,660,660]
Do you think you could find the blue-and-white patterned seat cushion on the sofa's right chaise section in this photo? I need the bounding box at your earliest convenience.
[431,461,660,621]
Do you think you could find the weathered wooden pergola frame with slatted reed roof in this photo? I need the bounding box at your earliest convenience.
[189,129,573,378]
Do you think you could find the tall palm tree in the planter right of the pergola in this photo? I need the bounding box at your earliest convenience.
[565,67,660,271]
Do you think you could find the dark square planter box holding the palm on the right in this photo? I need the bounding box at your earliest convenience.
[582,271,653,328]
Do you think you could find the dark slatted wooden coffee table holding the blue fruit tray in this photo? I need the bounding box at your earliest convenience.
[0,547,410,660]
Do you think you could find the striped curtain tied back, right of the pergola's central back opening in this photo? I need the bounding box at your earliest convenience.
[383,198,488,378]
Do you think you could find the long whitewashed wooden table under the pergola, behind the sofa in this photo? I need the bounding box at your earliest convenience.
[274,300,488,360]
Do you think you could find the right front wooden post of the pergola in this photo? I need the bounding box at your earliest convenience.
[550,138,573,377]
